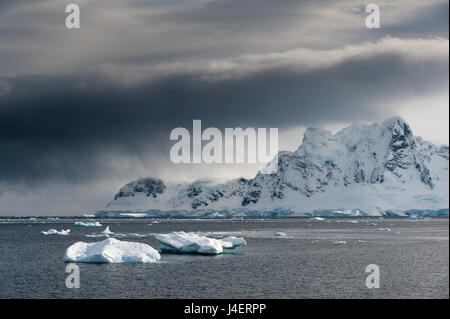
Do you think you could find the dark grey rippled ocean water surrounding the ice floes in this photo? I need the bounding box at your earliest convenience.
[0,218,449,298]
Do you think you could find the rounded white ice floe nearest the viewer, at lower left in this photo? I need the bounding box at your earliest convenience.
[64,238,161,263]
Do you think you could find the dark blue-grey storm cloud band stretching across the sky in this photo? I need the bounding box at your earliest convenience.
[0,39,449,185]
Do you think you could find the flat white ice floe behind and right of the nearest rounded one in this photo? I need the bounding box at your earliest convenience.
[155,231,246,255]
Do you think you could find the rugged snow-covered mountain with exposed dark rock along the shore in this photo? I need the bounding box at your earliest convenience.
[98,117,449,216]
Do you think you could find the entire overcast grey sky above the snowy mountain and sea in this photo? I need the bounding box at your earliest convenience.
[0,0,449,215]
